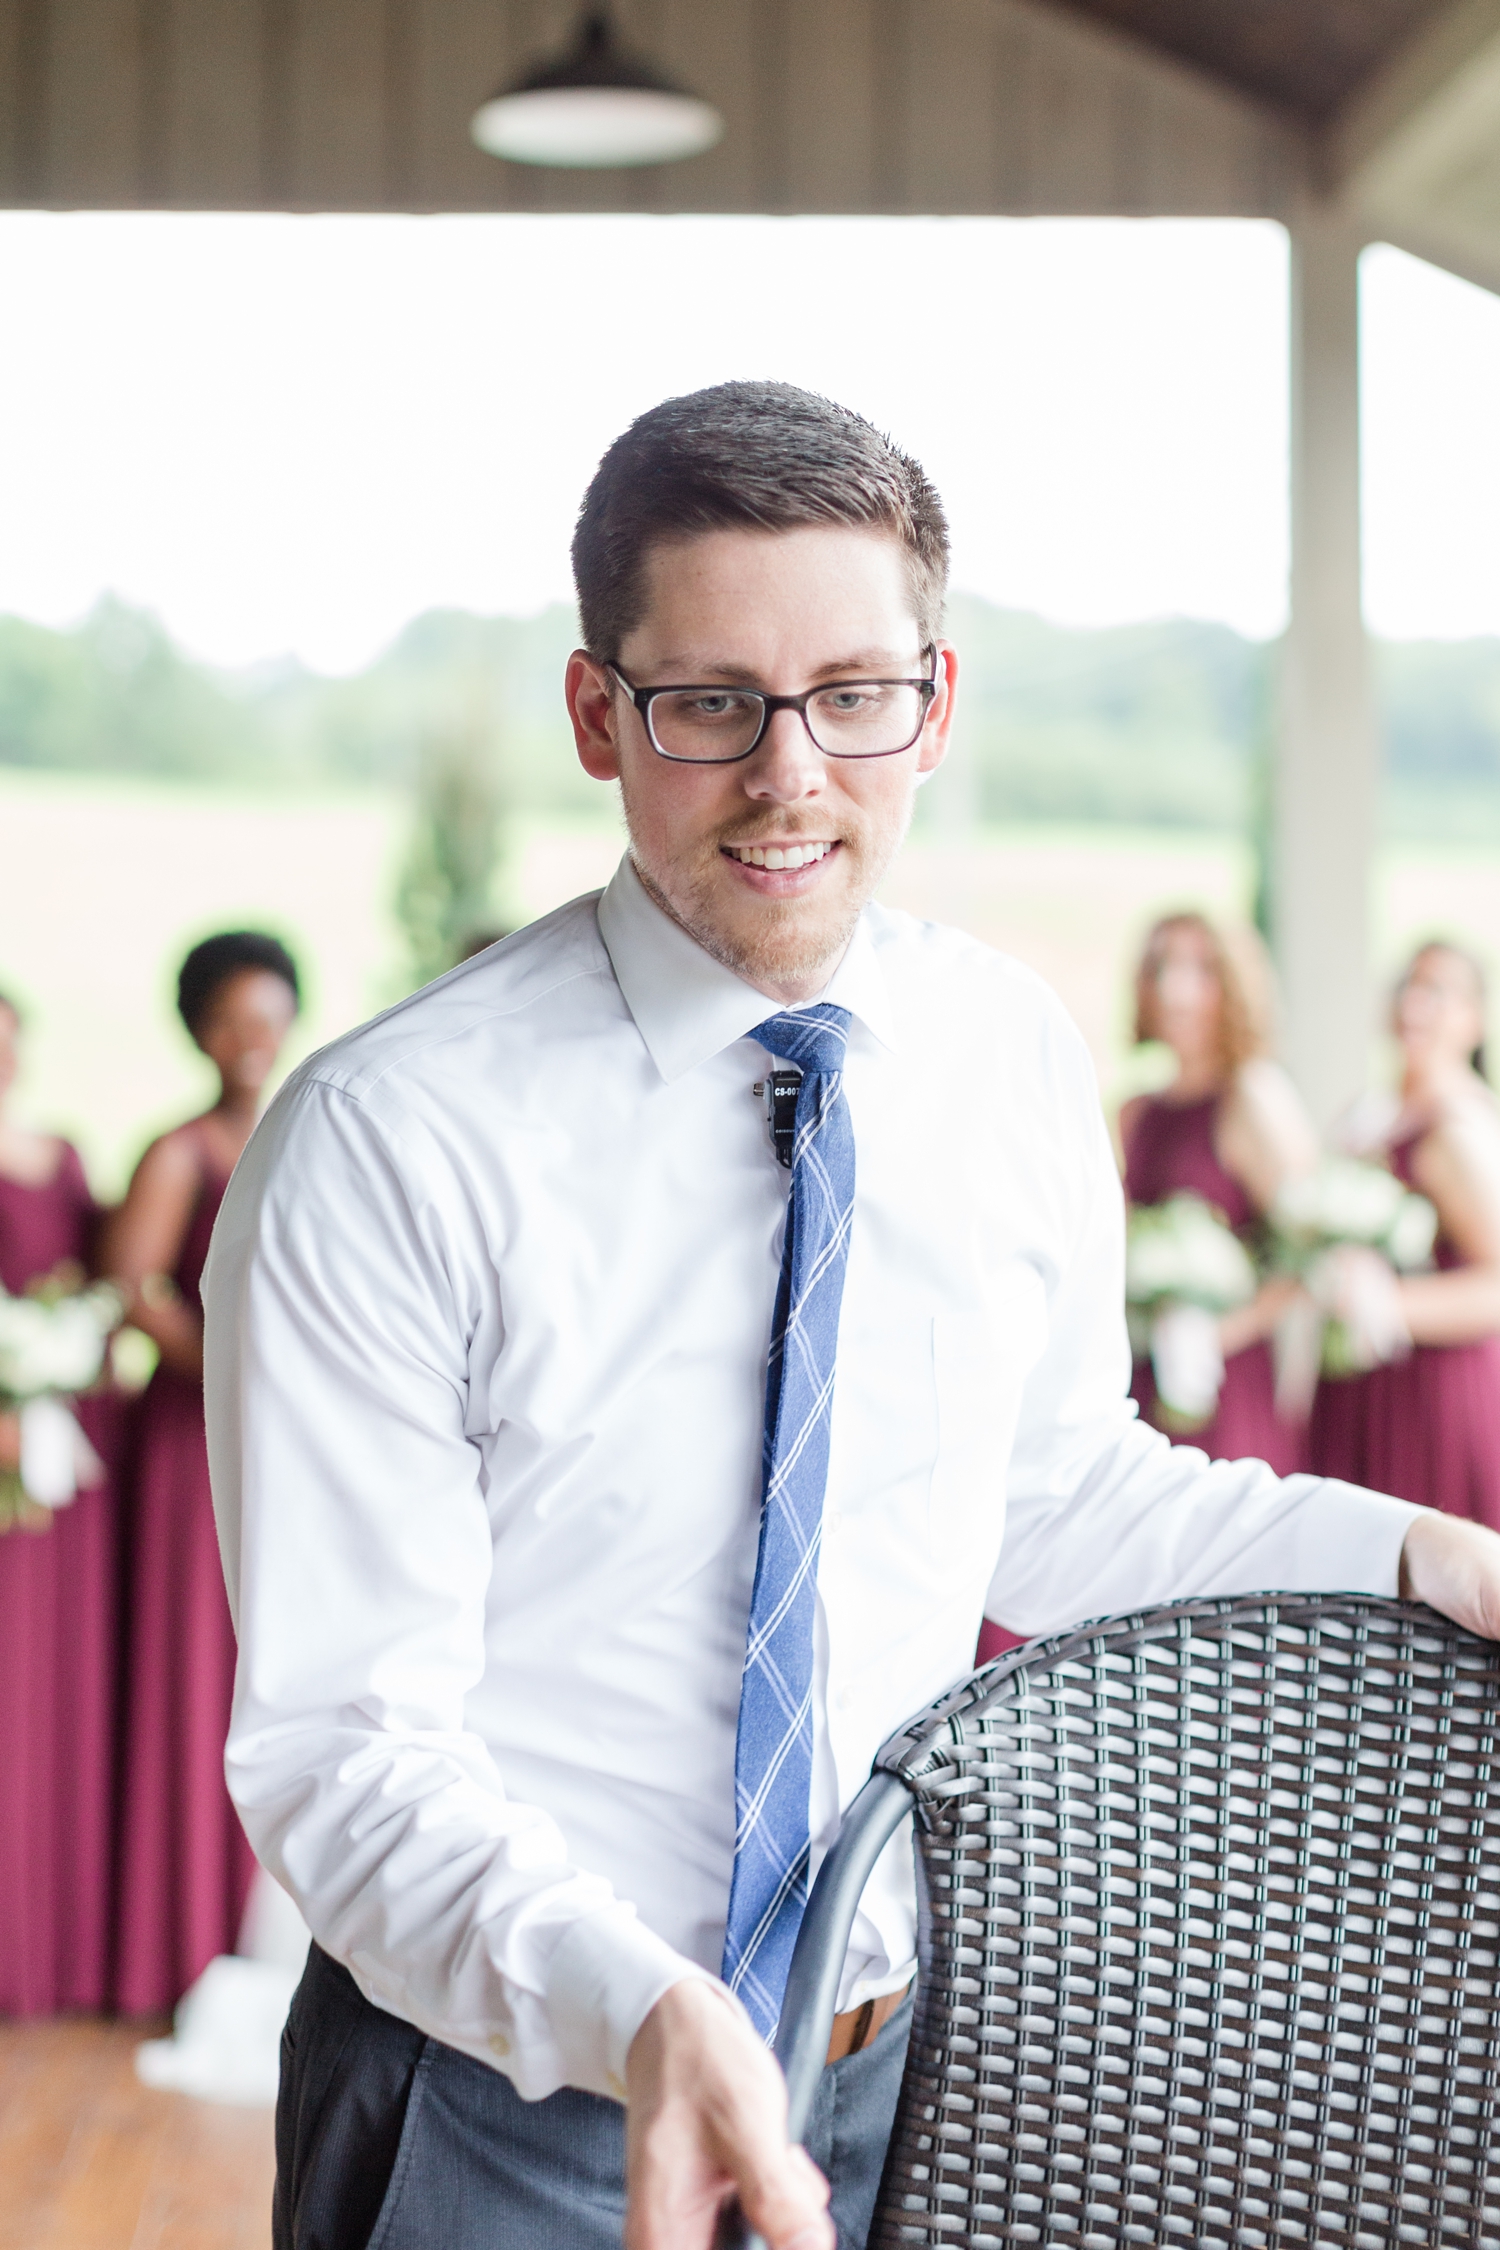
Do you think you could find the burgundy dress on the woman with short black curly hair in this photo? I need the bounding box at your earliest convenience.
[115,1136,254,2016]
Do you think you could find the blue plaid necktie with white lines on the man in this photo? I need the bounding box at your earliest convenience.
[724,1004,855,2039]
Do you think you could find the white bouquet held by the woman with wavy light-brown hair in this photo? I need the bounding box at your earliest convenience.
[1124,1195,1257,1433]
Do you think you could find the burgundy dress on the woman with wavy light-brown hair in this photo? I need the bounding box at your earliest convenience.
[1124,1094,1302,1476]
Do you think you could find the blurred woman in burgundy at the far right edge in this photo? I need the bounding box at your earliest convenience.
[1311,945,1500,1530]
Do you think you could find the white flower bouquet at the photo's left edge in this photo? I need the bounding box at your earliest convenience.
[0,1269,124,1532]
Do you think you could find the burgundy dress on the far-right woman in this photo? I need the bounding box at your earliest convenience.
[1311,1134,1500,1530]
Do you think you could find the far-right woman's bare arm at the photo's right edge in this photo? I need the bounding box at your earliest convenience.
[1401,1105,1500,1343]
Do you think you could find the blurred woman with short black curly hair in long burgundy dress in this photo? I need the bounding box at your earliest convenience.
[108,929,299,2014]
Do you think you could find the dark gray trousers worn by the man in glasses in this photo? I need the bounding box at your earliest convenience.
[272,1946,911,2250]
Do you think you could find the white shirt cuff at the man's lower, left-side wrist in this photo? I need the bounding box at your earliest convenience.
[546,1901,717,2102]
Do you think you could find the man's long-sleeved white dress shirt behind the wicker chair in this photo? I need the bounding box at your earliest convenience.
[205,862,1412,2097]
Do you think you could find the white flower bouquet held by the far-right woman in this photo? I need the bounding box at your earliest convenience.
[1271,1157,1437,1415]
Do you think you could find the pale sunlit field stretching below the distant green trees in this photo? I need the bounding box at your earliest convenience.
[0,772,1500,1195]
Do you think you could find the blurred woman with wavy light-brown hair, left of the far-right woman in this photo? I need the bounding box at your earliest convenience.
[1120,914,1318,1476]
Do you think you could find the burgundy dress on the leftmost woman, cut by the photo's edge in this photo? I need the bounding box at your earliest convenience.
[0,1145,119,2016]
